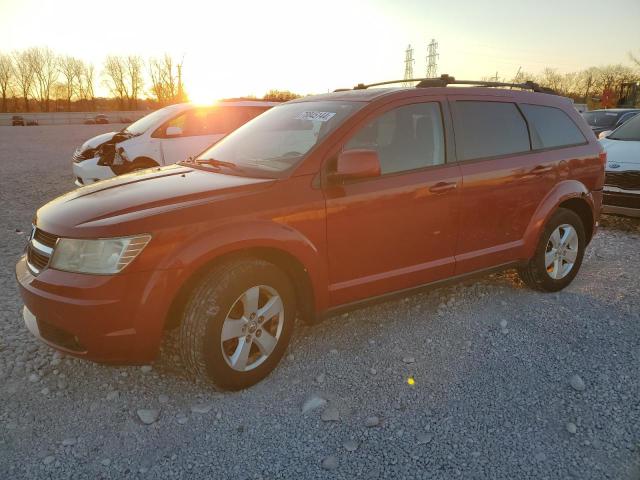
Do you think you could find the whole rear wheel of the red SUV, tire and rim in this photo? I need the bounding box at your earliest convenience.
[518,208,586,292]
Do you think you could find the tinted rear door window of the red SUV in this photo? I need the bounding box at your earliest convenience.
[454,101,530,160]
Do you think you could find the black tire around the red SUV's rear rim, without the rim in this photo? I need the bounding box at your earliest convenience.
[518,208,586,292]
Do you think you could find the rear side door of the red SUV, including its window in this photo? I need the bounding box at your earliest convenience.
[451,96,555,274]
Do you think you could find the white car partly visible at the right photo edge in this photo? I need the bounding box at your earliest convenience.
[600,115,640,217]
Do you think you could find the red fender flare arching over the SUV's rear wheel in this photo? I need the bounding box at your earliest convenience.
[523,180,594,260]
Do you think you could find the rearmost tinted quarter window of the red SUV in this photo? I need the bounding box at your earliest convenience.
[520,105,587,148]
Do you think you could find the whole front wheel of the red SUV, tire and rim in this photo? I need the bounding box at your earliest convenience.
[180,259,296,390]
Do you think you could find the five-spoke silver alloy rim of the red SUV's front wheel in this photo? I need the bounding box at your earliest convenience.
[220,285,284,372]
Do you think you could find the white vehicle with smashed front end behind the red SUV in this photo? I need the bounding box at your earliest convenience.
[73,100,277,186]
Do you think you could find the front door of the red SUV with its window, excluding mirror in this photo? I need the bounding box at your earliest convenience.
[325,100,461,306]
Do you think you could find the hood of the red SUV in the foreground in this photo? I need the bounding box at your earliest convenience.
[35,165,275,234]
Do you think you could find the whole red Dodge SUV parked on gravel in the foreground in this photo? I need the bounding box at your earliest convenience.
[16,76,605,389]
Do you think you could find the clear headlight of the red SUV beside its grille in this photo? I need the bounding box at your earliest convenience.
[49,234,151,275]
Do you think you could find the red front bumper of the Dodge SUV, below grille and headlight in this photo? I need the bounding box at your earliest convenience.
[16,256,171,364]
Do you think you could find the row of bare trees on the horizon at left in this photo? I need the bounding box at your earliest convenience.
[0,47,187,112]
